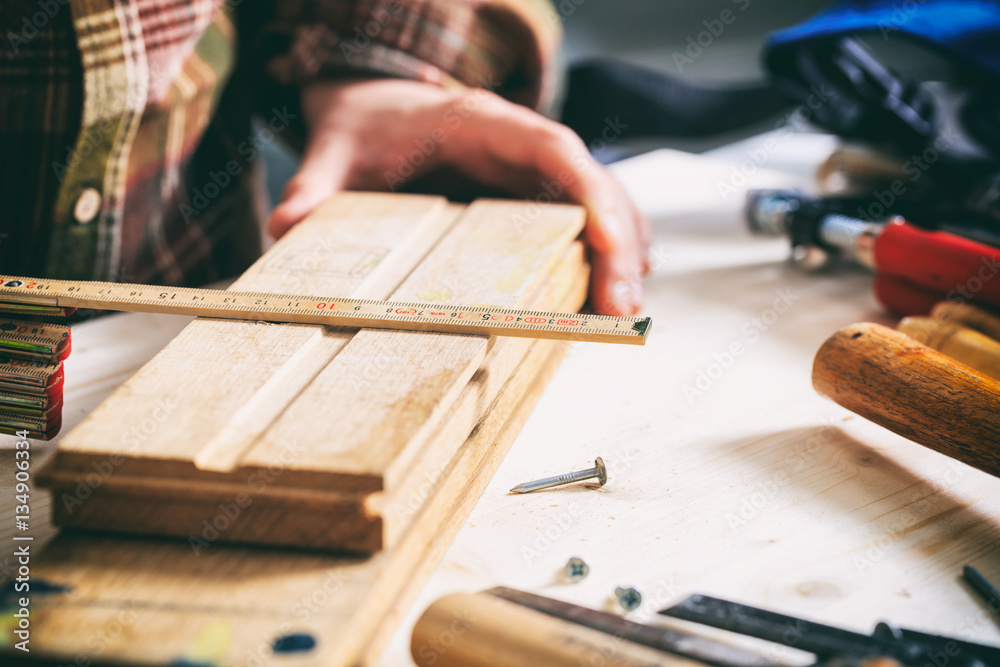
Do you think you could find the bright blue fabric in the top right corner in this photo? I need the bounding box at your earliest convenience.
[766,0,1000,76]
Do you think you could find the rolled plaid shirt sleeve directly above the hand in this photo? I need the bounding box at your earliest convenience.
[255,0,562,113]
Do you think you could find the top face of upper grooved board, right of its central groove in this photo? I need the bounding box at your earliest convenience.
[242,200,584,491]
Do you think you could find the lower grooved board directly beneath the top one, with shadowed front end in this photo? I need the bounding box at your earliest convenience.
[37,242,587,552]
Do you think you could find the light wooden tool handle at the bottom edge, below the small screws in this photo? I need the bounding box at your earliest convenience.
[410,593,703,667]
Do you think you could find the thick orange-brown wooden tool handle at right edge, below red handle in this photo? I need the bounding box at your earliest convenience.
[812,322,1000,476]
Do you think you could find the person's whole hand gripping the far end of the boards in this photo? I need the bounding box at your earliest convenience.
[268,79,650,315]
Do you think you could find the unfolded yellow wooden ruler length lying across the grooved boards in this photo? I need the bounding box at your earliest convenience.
[0,275,652,345]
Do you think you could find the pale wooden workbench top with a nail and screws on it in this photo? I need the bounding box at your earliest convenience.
[0,135,1000,666]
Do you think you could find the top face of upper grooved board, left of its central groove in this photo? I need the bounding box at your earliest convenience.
[46,193,456,476]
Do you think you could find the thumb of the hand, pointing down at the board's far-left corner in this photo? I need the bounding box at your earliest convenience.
[267,138,348,239]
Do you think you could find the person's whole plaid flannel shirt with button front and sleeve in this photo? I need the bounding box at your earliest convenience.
[0,0,559,285]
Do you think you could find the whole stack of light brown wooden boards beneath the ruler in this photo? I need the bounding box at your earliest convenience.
[19,194,587,665]
